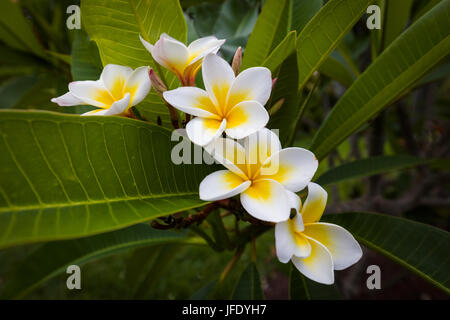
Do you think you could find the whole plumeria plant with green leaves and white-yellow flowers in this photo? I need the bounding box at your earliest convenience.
[0,0,450,299]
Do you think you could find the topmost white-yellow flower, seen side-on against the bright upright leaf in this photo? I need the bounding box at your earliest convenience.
[139,33,225,86]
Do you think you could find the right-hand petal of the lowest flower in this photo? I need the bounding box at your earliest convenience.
[304,223,362,270]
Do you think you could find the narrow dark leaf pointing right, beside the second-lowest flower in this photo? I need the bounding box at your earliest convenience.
[315,155,429,185]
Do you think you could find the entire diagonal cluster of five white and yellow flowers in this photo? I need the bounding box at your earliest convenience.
[52,34,362,284]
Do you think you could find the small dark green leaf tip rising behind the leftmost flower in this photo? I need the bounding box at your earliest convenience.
[71,30,102,81]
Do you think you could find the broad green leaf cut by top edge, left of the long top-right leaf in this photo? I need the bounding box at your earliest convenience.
[297,0,374,88]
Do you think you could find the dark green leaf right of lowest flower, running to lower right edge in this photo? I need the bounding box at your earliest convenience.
[323,212,450,293]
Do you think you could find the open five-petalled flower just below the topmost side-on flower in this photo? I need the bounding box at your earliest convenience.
[163,54,272,146]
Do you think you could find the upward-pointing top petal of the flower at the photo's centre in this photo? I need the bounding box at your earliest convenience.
[242,128,281,175]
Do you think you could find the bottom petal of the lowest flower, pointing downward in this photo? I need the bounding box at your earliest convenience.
[292,238,334,284]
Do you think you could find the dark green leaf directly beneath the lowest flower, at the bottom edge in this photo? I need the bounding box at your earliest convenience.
[289,266,342,300]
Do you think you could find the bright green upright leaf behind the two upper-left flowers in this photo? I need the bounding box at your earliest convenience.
[81,0,187,127]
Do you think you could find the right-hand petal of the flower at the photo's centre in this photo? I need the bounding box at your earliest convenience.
[261,148,319,192]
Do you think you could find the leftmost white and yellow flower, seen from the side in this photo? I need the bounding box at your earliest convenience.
[51,64,151,116]
